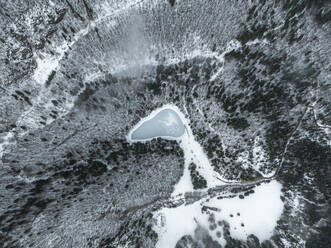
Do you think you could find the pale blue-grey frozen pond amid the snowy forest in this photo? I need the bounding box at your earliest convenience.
[129,108,185,141]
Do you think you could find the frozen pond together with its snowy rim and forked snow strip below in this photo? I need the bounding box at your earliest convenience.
[127,104,221,196]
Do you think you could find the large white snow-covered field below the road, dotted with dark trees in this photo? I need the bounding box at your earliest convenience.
[154,181,284,248]
